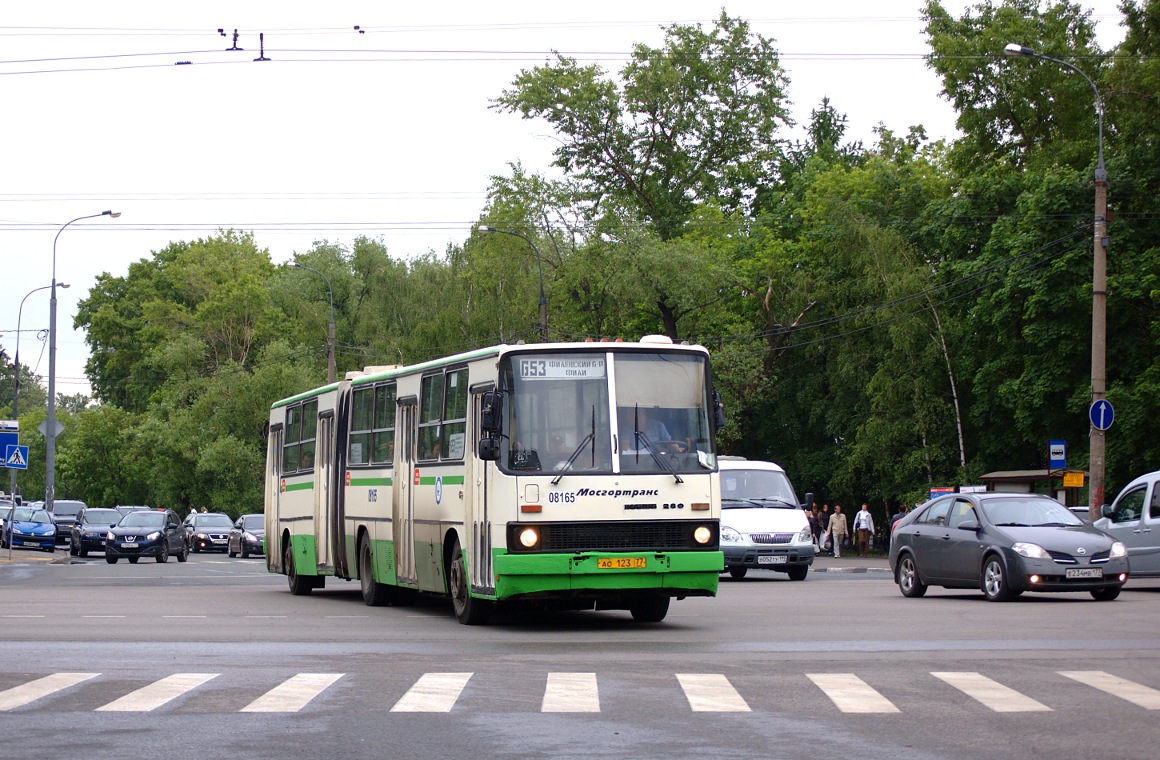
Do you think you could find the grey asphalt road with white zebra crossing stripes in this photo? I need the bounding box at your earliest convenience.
[0,550,1160,760]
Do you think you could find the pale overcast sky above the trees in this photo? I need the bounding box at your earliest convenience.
[0,0,1123,393]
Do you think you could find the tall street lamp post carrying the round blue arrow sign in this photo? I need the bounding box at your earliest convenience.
[1003,43,1108,520]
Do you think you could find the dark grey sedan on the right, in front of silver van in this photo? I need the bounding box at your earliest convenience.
[890,492,1129,601]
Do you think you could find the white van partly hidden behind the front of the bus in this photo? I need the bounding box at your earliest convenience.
[717,456,815,580]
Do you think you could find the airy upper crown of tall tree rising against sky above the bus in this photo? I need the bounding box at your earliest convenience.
[495,13,789,240]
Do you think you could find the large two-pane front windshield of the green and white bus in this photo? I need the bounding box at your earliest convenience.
[500,350,716,475]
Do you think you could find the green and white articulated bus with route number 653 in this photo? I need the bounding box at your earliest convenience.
[266,335,724,624]
